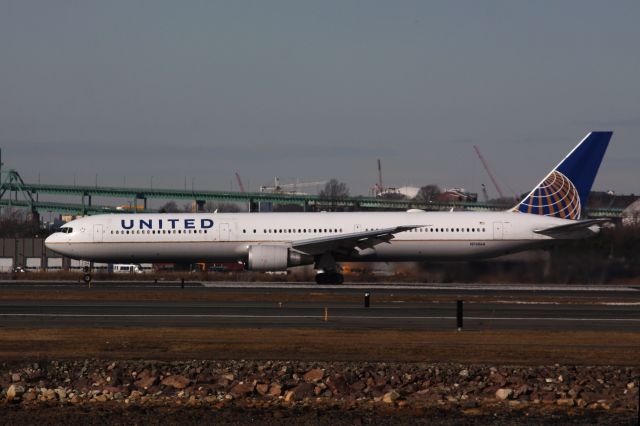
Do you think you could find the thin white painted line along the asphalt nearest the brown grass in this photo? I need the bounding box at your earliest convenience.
[0,314,640,323]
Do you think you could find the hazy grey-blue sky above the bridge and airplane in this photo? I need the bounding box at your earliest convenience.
[0,0,640,197]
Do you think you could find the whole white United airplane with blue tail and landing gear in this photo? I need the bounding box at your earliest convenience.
[45,131,613,284]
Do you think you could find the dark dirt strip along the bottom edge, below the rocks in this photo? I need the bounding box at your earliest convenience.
[0,404,637,426]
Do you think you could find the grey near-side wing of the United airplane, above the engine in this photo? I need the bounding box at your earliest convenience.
[291,225,424,256]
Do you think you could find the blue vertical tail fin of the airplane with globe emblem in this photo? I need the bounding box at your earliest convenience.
[512,132,613,220]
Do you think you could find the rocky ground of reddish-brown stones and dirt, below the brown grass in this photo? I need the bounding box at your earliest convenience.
[0,359,640,425]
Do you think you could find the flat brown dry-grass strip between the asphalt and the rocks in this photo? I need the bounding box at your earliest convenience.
[0,328,640,366]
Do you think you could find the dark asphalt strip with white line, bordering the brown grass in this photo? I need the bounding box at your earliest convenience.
[0,301,640,332]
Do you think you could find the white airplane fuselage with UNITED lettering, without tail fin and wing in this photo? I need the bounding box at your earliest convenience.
[46,211,573,263]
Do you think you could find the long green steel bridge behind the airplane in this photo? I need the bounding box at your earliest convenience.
[0,170,622,218]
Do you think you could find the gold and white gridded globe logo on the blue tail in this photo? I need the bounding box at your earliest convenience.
[514,170,581,220]
